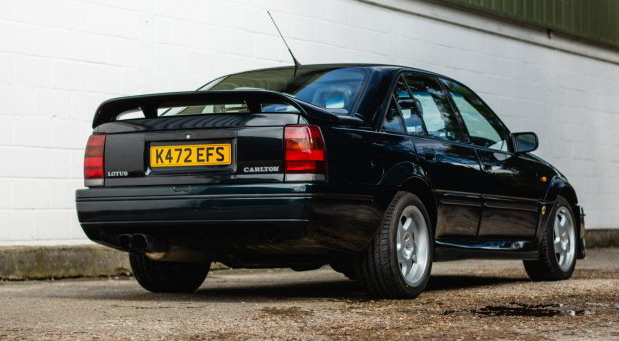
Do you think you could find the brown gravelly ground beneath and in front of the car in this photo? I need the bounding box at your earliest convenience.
[0,249,619,340]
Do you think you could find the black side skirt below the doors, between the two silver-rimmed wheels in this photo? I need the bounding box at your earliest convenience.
[434,239,539,261]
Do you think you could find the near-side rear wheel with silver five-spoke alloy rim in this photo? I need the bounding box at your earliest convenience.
[356,192,434,299]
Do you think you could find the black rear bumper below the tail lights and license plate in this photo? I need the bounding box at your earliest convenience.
[76,183,382,251]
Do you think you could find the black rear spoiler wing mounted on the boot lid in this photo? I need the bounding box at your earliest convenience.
[92,90,340,128]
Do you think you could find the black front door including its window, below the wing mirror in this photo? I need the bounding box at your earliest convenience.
[441,79,545,240]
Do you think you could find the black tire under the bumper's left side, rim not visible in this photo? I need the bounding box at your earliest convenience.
[129,253,211,293]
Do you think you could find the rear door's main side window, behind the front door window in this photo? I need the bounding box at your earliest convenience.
[405,74,464,141]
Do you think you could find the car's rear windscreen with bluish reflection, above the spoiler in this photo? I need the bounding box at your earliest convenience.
[200,67,367,115]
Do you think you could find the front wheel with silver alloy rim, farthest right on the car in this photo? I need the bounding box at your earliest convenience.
[524,196,578,281]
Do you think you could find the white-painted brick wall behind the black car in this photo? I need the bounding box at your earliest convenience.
[0,0,619,244]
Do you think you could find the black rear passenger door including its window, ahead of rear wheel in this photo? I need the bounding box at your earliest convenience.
[398,72,481,240]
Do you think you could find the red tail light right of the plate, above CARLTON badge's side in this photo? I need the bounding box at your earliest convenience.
[284,125,327,181]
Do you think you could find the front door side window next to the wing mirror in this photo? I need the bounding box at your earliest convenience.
[441,79,509,151]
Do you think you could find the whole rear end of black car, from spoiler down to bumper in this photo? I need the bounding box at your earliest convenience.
[76,82,380,266]
